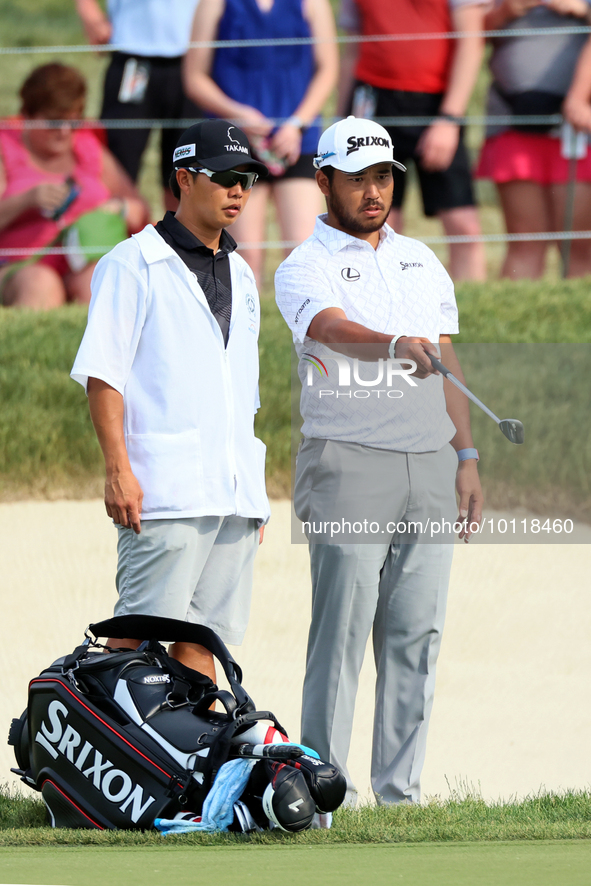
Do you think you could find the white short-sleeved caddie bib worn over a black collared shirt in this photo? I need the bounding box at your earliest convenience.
[71,225,269,521]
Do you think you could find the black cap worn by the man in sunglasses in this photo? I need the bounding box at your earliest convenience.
[172,120,268,175]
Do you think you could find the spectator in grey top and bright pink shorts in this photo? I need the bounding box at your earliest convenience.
[476,0,591,279]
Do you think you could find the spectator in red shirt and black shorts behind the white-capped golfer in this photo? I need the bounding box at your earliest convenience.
[338,0,486,280]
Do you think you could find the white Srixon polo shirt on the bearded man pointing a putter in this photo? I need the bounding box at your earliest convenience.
[275,215,459,452]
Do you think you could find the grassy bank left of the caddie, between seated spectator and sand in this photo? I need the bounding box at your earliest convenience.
[0,308,102,498]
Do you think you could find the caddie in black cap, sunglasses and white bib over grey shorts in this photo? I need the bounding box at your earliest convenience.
[72,120,269,679]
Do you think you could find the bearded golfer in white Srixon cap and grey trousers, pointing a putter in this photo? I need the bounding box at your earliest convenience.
[275,117,482,804]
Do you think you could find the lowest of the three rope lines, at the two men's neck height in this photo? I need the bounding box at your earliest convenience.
[0,231,591,258]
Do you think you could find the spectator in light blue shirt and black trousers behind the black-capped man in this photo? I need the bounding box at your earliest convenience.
[76,0,201,209]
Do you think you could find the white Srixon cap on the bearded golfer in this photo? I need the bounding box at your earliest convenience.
[314,116,406,172]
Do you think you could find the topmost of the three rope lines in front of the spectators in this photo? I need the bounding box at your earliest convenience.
[0,25,591,55]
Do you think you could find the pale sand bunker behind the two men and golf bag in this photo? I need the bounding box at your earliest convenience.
[0,501,591,799]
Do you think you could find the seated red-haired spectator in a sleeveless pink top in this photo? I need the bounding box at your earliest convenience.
[0,63,148,309]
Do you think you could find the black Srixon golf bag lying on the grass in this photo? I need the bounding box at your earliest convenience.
[8,616,345,830]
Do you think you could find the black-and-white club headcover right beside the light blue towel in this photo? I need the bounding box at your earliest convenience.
[240,759,316,832]
